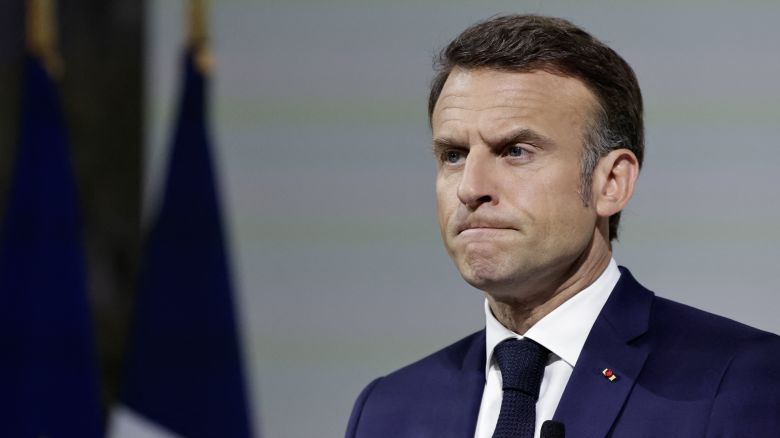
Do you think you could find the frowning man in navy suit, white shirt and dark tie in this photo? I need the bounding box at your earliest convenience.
[347,15,780,438]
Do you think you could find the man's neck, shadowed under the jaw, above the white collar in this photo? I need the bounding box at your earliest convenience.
[486,238,612,335]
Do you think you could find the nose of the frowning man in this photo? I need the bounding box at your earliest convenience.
[458,147,498,210]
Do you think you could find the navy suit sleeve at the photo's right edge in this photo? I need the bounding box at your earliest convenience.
[707,334,780,438]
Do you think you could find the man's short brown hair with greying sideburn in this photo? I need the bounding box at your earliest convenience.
[428,15,644,240]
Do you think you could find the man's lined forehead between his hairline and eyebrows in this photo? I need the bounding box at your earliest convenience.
[431,68,596,143]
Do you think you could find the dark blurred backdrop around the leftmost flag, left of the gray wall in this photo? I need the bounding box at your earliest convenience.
[0,0,146,424]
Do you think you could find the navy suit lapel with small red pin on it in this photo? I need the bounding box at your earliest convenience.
[553,268,653,438]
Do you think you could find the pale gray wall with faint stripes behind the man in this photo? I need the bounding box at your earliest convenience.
[145,0,780,438]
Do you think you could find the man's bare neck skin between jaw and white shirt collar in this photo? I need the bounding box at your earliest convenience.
[484,226,612,335]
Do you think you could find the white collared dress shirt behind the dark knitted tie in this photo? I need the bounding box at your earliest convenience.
[474,259,620,438]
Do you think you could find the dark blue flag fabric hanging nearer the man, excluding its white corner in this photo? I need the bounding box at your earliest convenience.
[122,49,251,438]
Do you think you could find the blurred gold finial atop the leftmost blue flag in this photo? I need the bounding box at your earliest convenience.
[25,0,63,77]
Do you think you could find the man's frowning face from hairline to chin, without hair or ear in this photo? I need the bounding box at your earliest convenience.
[432,68,597,299]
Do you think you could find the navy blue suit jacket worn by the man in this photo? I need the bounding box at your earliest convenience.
[346,268,780,438]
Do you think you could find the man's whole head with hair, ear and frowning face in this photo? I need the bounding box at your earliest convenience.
[429,16,643,298]
